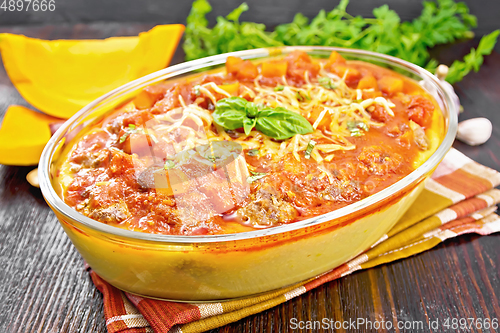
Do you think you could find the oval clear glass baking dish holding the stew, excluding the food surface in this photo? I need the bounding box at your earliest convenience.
[39,47,458,302]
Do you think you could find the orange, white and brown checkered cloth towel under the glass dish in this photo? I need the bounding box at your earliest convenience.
[90,149,500,333]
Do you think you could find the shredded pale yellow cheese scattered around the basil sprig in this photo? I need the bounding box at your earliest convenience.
[146,64,395,173]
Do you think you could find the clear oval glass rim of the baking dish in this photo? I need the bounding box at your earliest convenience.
[38,46,458,244]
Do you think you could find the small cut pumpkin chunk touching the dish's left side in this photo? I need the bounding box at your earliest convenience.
[0,105,61,165]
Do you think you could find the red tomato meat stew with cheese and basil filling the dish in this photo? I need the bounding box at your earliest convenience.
[58,51,442,235]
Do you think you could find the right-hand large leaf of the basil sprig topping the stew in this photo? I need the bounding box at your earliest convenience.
[255,107,313,140]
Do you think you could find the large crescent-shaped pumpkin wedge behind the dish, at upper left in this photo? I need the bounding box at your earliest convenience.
[0,24,184,118]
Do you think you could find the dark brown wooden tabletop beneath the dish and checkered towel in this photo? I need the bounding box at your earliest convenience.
[0,24,500,332]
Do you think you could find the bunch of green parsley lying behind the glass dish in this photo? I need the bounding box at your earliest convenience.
[183,0,500,83]
